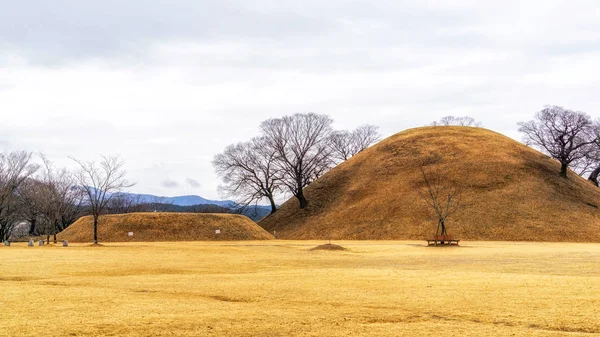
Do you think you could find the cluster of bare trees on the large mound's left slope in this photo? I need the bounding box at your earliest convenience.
[213,113,380,213]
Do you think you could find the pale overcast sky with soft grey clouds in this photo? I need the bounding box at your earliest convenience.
[0,0,600,198]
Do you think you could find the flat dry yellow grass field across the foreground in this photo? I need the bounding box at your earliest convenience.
[0,241,600,337]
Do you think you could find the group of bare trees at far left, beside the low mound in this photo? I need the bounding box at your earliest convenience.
[0,151,130,242]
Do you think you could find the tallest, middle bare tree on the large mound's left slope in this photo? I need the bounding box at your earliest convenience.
[260,113,333,208]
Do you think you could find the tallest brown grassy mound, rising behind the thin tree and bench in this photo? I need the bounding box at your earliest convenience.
[260,127,600,242]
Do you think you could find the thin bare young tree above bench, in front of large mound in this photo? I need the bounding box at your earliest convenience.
[417,166,463,239]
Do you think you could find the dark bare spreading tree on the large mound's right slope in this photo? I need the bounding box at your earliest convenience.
[519,106,597,178]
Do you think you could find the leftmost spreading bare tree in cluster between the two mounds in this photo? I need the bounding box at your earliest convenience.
[212,137,282,214]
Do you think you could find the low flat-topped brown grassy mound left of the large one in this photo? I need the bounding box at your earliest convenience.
[58,213,273,242]
